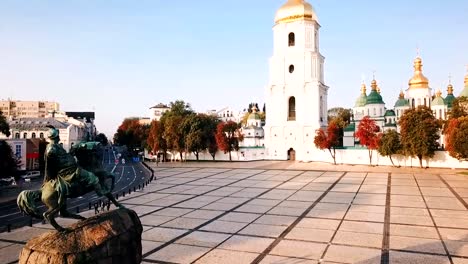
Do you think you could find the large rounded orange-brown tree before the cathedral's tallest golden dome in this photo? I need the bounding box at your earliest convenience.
[399,106,441,168]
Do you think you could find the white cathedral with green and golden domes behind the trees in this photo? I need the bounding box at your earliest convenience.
[343,56,468,147]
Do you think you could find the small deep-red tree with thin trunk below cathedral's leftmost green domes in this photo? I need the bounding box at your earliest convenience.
[356,116,380,165]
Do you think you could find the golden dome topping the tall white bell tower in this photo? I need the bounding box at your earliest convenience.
[275,0,318,24]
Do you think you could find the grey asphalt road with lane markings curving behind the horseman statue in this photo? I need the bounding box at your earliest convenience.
[0,147,151,232]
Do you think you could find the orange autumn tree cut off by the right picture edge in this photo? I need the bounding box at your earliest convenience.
[445,116,468,160]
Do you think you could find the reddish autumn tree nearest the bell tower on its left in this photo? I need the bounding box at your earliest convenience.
[216,121,244,161]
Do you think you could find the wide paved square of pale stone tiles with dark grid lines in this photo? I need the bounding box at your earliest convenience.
[0,167,468,264]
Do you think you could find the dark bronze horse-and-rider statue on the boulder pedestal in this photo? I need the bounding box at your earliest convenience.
[17,127,123,231]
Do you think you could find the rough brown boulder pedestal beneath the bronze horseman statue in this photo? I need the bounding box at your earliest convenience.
[19,209,143,264]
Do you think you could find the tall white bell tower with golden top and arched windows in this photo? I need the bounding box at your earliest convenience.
[264,0,328,161]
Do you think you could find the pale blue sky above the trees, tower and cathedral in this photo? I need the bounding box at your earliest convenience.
[0,0,468,136]
